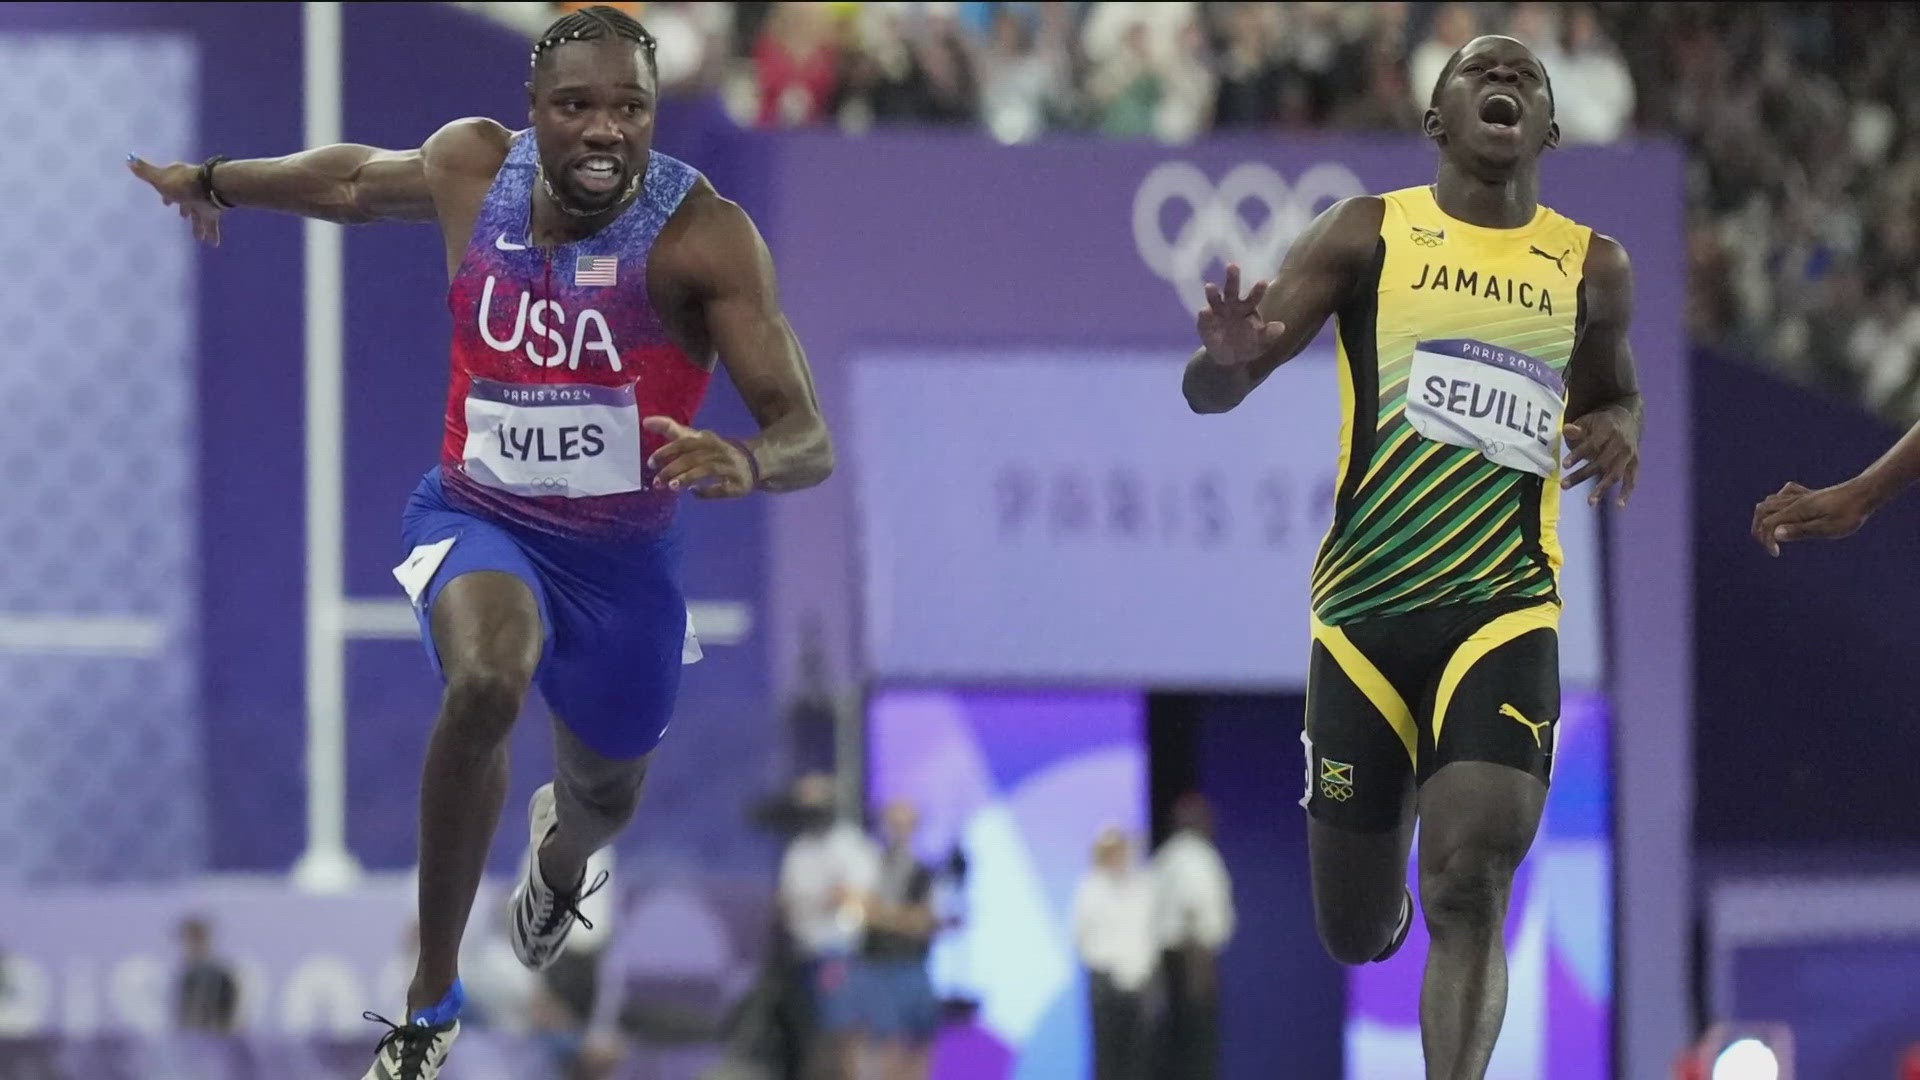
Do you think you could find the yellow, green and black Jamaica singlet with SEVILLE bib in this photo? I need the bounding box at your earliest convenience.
[1313,186,1592,626]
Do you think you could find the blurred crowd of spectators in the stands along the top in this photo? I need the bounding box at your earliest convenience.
[464,0,1920,419]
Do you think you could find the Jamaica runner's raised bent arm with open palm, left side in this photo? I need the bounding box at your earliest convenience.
[1181,196,1384,413]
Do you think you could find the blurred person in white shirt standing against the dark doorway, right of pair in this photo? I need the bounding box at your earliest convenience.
[1154,794,1235,1080]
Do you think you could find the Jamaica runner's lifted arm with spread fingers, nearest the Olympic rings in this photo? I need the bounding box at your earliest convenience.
[1181,196,1386,413]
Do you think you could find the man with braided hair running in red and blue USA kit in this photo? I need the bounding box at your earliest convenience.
[131,8,833,1080]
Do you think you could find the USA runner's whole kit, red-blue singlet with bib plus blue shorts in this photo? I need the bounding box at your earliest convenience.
[394,133,708,759]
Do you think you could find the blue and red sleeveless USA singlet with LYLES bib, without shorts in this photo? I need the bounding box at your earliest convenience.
[440,133,710,538]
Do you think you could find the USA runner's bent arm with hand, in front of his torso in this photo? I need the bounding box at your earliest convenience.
[645,190,833,498]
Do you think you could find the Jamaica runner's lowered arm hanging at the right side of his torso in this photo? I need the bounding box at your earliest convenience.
[1561,233,1642,505]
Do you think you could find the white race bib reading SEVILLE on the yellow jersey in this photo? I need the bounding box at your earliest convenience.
[1407,338,1567,477]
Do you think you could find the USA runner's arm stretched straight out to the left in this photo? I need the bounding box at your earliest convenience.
[127,117,509,244]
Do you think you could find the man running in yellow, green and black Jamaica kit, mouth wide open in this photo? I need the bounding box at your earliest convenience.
[1185,37,1640,1080]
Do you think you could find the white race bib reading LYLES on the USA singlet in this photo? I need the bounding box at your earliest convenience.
[463,379,645,500]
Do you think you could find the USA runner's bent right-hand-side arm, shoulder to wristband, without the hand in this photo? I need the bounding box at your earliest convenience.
[662,190,833,492]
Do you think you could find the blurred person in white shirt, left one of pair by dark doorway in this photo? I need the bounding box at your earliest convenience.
[1073,828,1160,1080]
